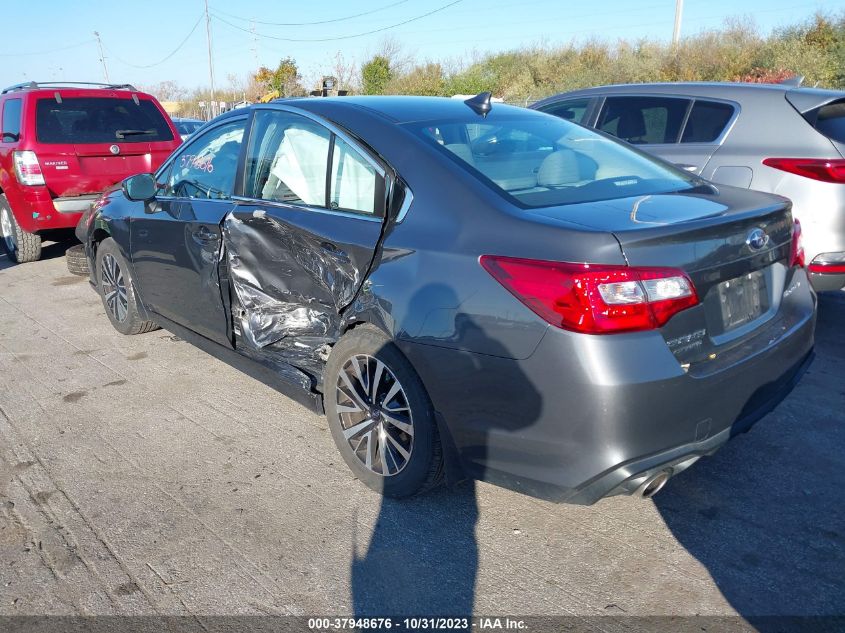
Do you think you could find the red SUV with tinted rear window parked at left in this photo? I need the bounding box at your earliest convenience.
[0,82,181,262]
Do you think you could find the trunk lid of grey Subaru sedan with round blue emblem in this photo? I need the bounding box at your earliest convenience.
[541,186,792,362]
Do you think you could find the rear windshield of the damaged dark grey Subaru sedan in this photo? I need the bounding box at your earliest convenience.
[415,115,697,207]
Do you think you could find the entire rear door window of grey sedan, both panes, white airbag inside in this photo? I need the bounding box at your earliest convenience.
[245,110,379,215]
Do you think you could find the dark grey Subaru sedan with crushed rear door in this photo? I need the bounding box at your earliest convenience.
[78,95,815,503]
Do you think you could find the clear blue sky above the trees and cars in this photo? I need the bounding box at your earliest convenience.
[0,0,845,88]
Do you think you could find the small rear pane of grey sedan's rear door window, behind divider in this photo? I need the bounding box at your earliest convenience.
[329,136,379,215]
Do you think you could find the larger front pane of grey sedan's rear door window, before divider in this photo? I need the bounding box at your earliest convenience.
[246,110,332,207]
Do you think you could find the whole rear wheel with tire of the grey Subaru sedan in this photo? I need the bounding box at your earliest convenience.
[323,325,443,498]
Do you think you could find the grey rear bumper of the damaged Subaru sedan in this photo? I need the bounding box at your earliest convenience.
[398,272,815,504]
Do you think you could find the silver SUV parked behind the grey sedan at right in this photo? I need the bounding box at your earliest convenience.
[531,82,845,290]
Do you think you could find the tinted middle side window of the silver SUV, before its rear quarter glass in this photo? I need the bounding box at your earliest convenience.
[596,97,690,144]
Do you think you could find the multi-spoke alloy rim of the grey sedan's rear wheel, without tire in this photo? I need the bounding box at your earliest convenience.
[335,354,414,477]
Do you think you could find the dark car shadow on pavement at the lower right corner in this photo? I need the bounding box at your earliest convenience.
[654,293,845,632]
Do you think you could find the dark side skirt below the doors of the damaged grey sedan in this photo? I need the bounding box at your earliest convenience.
[151,313,324,415]
